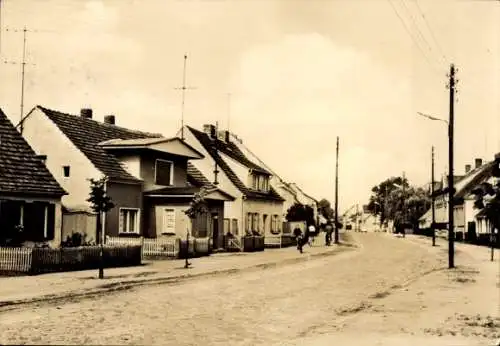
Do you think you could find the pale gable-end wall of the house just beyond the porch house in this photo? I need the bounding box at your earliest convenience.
[184,128,244,235]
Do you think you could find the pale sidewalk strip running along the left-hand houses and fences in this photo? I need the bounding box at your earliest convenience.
[0,238,355,307]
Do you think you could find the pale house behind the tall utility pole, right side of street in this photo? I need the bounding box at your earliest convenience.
[419,158,496,241]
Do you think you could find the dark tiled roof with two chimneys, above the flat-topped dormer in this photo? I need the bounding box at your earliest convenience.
[36,106,162,182]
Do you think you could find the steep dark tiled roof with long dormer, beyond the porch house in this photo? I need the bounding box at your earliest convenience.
[186,126,284,201]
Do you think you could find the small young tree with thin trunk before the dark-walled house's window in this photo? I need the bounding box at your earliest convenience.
[87,177,115,279]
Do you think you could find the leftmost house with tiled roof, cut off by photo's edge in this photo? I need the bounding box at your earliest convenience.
[0,109,66,247]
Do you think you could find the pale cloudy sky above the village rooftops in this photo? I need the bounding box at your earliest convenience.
[0,0,500,210]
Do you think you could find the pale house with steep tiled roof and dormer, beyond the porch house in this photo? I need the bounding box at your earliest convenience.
[183,124,284,243]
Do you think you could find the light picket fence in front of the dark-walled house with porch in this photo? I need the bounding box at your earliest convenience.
[106,236,179,258]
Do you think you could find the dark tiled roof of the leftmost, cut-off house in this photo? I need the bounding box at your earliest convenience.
[0,109,67,197]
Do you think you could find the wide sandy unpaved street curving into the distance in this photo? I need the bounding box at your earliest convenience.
[0,234,500,345]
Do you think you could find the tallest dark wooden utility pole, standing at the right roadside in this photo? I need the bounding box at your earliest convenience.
[448,64,455,269]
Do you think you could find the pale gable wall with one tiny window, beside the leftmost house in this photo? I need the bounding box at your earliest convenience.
[23,108,101,210]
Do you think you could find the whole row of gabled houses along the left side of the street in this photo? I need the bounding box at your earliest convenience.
[0,106,317,249]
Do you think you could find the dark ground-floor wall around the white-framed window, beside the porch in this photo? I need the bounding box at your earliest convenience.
[104,182,145,237]
